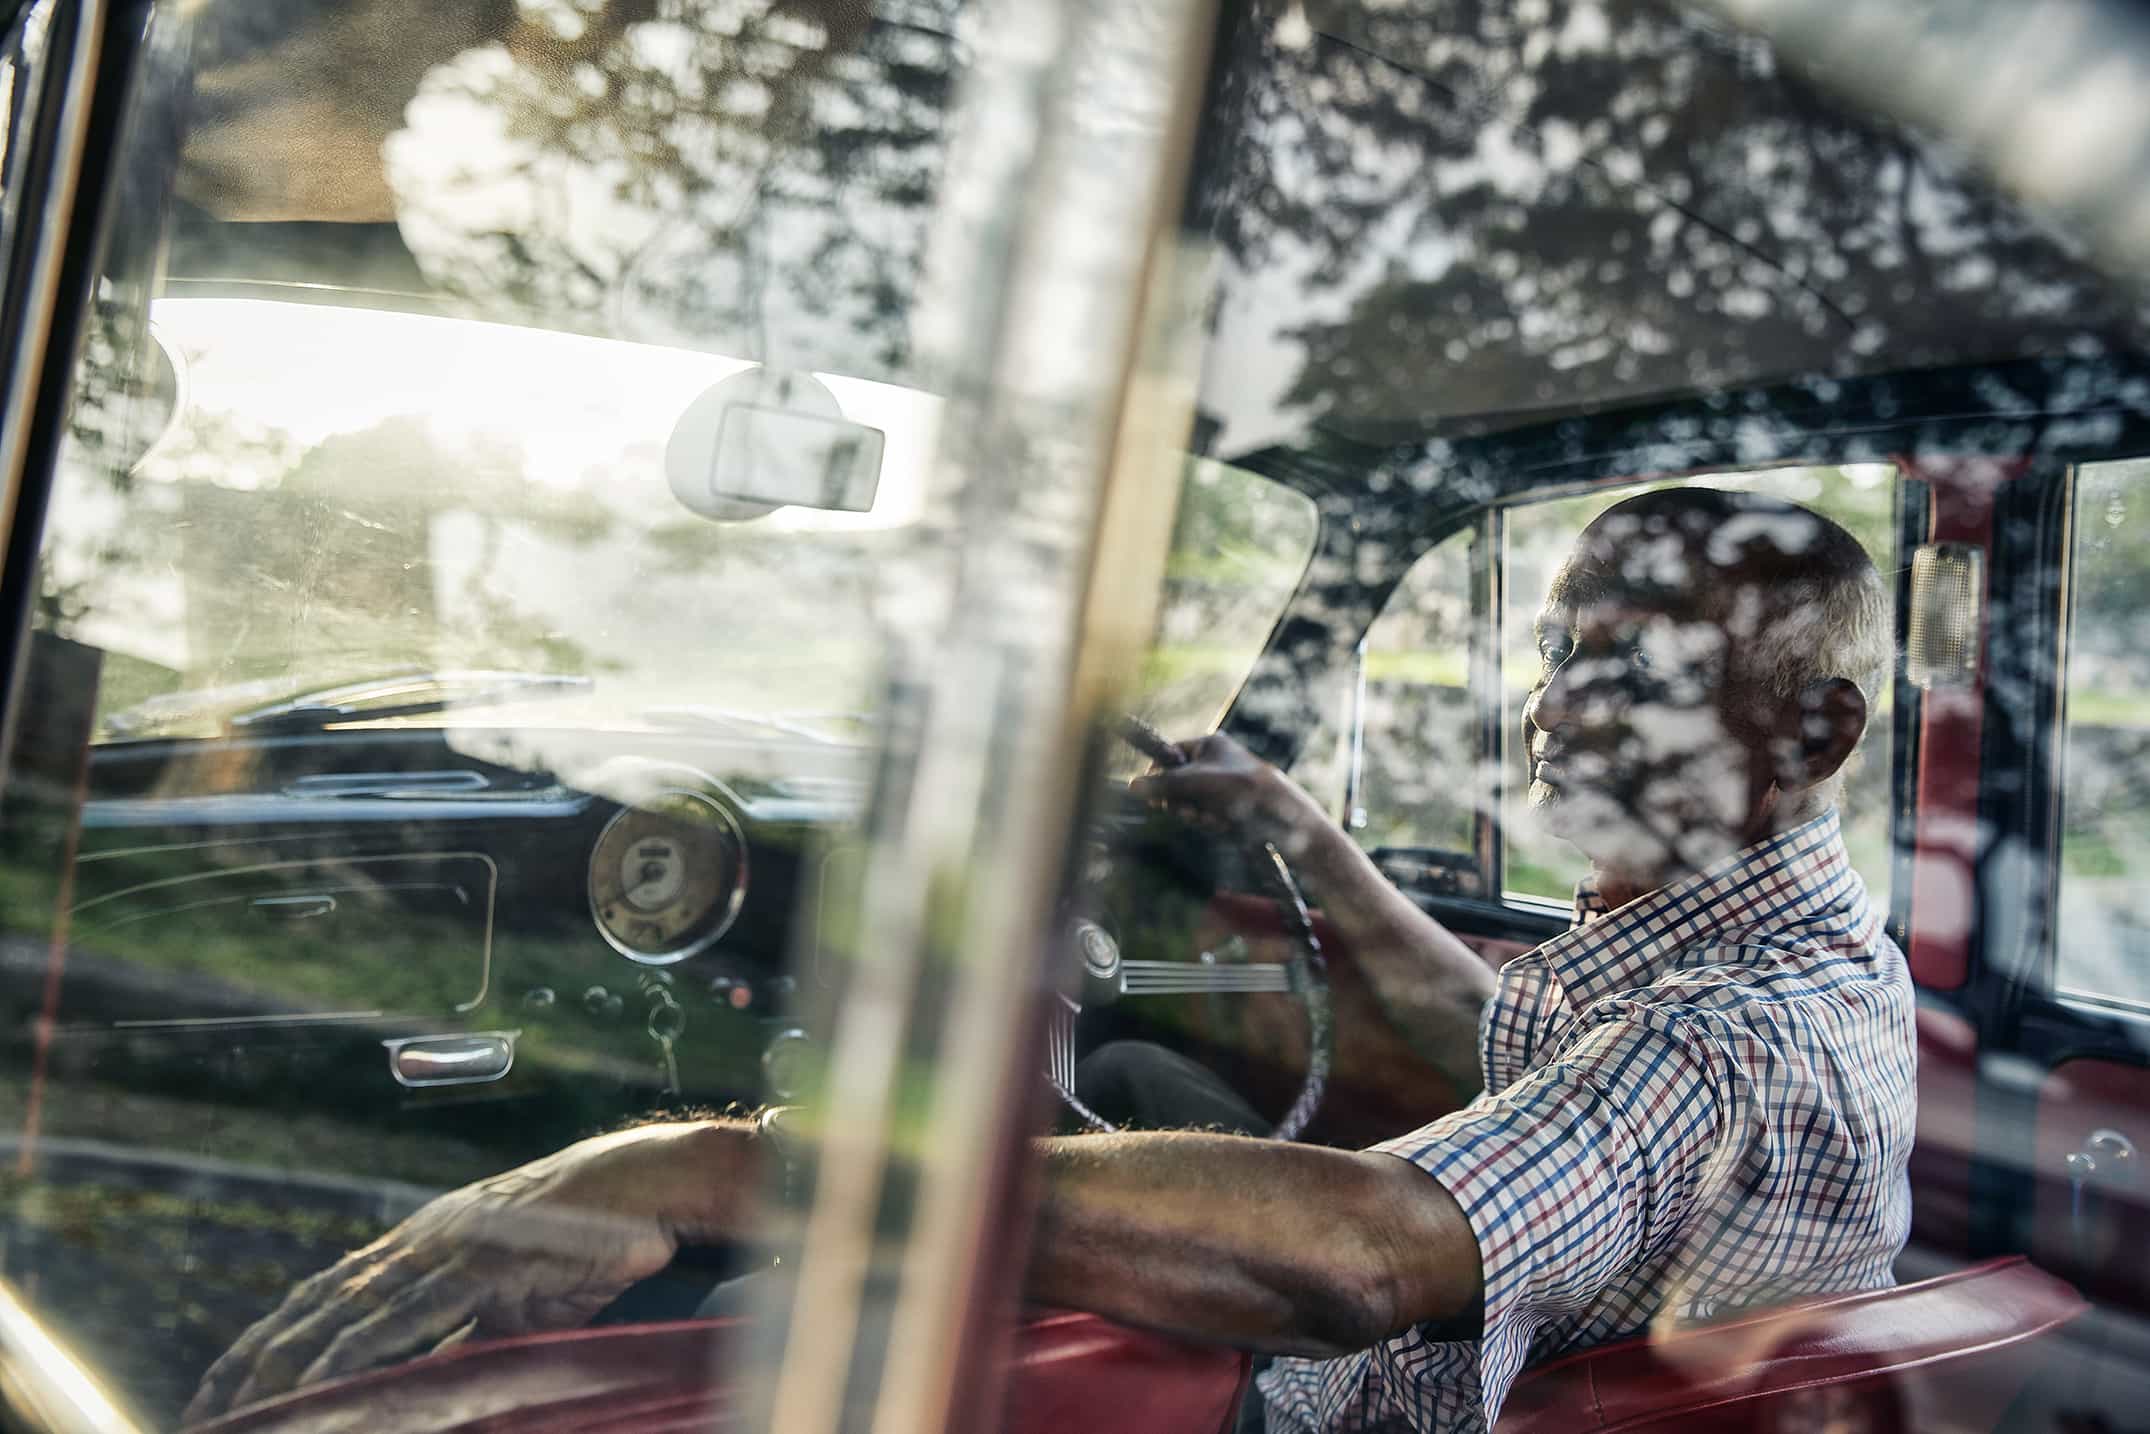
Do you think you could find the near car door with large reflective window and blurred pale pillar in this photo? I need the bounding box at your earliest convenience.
[0,0,1245,1430]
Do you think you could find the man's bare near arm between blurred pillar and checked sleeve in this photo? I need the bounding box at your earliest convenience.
[1030,1133,1479,1357]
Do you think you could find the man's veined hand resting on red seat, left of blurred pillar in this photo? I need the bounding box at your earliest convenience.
[185,1122,750,1423]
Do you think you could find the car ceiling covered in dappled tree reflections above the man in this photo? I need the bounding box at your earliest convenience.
[1202,0,2150,470]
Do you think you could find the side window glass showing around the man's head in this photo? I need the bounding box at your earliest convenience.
[1501,464,1896,909]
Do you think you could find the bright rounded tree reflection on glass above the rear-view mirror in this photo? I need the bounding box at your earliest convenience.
[383,0,959,374]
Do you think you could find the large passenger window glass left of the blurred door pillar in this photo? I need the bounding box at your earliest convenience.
[0,0,984,1428]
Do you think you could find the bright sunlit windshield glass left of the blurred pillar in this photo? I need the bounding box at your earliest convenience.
[45,297,940,735]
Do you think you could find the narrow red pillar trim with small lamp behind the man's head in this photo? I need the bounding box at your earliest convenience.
[1901,456,2030,991]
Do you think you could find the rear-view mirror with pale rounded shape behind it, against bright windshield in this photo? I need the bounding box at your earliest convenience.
[664,370,884,520]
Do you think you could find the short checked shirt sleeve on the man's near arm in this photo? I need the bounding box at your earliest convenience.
[1374,1008,1737,1425]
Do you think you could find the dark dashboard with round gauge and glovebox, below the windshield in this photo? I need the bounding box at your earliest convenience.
[12,727,864,1159]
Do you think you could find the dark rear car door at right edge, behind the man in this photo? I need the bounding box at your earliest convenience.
[1950,449,2150,1417]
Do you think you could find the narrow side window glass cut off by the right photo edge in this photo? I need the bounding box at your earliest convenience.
[2053,458,2150,1004]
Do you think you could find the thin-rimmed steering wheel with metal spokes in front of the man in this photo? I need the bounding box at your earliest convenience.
[1045,718,1335,1139]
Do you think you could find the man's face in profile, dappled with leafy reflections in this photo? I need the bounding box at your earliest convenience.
[1522,510,1769,875]
